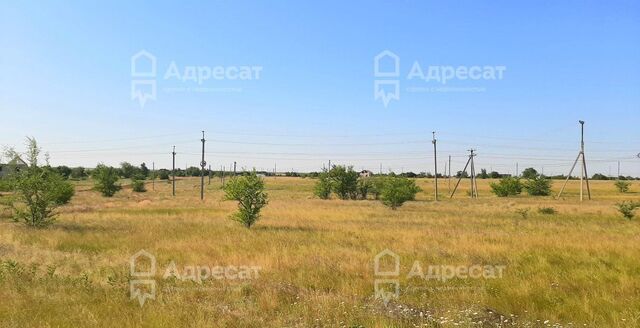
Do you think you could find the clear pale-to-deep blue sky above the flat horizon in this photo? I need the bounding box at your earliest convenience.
[0,1,640,176]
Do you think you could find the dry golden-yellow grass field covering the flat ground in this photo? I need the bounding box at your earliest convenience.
[0,178,640,327]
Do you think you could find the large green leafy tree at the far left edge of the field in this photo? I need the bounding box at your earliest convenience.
[7,138,74,227]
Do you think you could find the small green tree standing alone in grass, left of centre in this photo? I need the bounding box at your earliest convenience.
[224,171,268,228]
